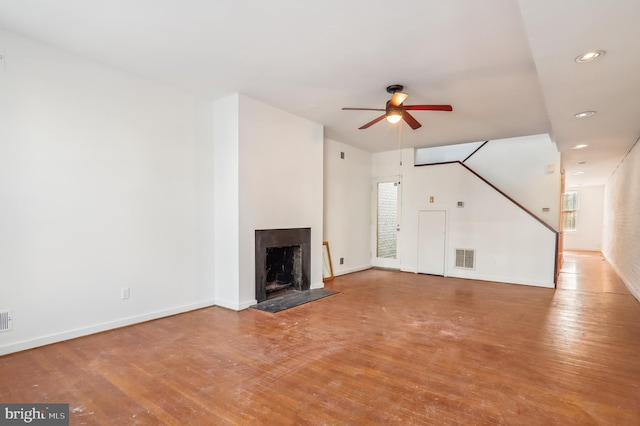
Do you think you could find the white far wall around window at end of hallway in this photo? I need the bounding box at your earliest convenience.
[563,185,604,251]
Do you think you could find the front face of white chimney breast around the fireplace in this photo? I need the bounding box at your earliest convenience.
[239,95,324,308]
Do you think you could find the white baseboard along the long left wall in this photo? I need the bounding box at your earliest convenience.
[0,300,214,356]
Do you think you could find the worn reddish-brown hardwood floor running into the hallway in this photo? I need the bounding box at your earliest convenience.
[0,252,640,425]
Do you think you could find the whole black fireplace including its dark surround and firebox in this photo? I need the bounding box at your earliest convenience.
[255,228,311,303]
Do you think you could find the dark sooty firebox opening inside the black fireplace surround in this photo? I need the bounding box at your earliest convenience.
[265,246,302,299]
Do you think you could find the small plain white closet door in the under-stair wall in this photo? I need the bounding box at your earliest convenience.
[418,210,447,276]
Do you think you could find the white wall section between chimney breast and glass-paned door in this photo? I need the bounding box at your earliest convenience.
[323,139,371,276]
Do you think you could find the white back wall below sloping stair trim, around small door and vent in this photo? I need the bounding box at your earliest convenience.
[373,145,556,287]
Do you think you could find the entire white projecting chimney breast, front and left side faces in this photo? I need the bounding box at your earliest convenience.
[214,95,323,309]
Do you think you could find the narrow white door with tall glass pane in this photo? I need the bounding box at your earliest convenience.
[371,176,401,269]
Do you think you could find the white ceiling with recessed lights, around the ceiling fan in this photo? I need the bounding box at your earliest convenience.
[0,0,640,186]
